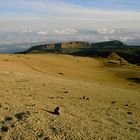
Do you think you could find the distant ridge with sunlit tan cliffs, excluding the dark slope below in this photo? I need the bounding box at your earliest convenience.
[19,40,126,53]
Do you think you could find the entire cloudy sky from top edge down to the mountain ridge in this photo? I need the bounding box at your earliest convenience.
[0,0,140,51]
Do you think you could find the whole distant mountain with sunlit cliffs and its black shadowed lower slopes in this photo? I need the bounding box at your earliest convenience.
[19,40,140,65]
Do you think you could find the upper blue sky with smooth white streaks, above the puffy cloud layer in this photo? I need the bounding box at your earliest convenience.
[0,0,140,31]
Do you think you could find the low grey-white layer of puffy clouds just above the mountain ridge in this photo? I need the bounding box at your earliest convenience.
[0,28,140,46]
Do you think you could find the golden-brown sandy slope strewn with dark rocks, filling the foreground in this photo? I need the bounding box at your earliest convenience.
[0,54,140,140]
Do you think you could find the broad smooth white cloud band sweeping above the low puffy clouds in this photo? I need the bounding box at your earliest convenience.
[0,0,140,30]
